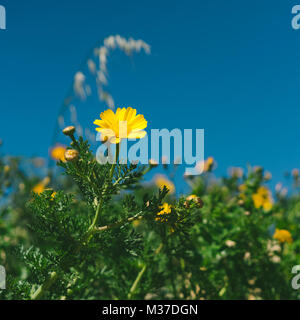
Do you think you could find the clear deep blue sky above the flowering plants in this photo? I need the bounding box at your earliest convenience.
[0,0,300,190]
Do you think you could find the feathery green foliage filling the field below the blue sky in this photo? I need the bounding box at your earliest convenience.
[0,138,300,299]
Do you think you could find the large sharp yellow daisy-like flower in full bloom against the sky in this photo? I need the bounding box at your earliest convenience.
[94,107,147,143]
